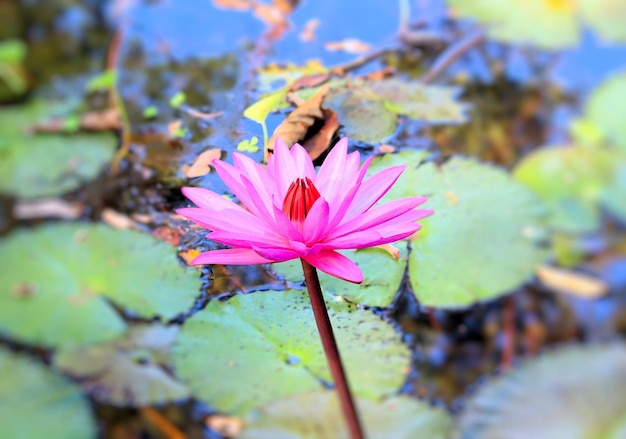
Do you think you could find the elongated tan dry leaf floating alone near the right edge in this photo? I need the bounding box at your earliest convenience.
[535,265,609,299]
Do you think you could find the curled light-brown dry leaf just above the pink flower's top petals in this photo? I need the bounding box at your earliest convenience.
[268,85,328,156]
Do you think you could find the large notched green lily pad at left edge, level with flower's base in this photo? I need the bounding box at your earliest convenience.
[0,224,200,347]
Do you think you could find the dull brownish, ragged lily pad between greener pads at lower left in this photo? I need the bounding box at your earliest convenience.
[54,324,189,407]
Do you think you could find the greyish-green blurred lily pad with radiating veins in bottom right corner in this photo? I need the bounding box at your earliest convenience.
[458,344,626,439]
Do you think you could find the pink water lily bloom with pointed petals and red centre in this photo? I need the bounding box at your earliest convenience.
[176,138,433,283]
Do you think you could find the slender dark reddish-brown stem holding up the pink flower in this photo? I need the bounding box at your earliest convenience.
[301,259,365,439]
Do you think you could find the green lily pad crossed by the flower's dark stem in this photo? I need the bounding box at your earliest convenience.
[172,290,410,414]
